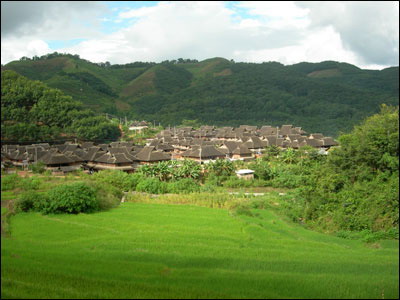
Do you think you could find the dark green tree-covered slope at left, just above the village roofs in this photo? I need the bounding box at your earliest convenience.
[1,70,120,142]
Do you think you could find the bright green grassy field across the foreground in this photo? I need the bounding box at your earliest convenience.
[1,203,399,299]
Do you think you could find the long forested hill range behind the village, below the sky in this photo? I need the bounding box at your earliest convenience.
[3,53,399,137]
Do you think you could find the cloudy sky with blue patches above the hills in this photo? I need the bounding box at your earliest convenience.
[1,1,399,69]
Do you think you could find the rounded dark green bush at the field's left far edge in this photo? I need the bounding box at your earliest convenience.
[41,182,99,214]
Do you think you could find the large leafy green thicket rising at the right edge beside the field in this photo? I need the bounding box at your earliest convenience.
[293,106,399,231]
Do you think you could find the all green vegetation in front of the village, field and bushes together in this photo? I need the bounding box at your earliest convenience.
[1,99,399,299]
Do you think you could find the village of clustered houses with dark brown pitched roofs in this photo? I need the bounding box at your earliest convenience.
[1,125,338,173]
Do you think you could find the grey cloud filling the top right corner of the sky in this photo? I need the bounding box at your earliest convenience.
[299,1,399,65]
